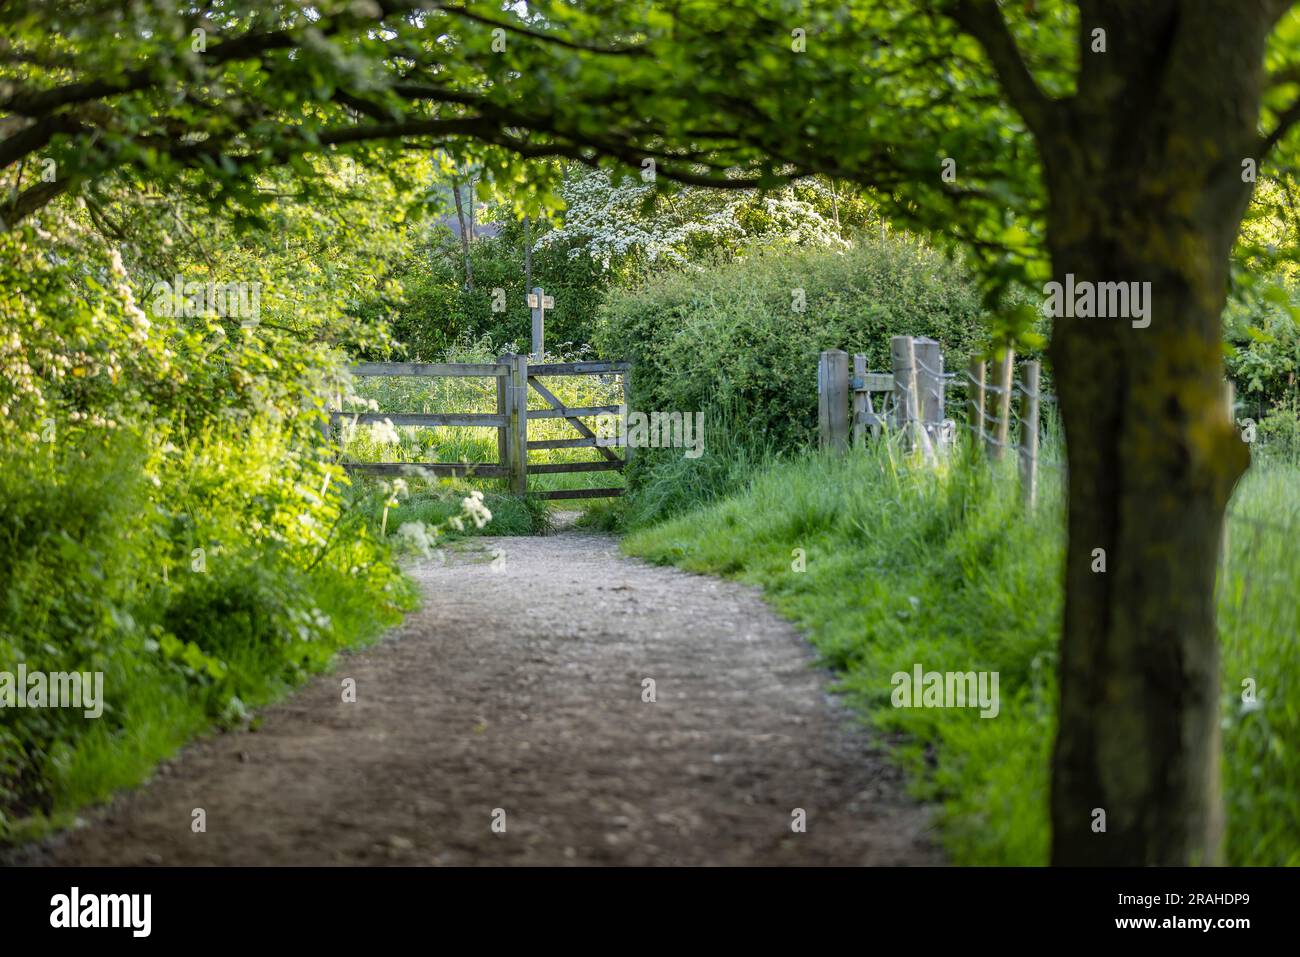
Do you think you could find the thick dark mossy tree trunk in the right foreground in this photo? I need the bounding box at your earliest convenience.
[1040,3,1268,865]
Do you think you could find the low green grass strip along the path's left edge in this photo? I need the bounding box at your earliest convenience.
[0,555,416,844]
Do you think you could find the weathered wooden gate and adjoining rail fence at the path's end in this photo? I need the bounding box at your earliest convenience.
[330,352,632,499]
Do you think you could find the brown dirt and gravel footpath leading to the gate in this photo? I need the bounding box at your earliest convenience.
[15,531,940,865]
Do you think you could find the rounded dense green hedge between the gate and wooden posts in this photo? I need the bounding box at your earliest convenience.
[593,237,987,450]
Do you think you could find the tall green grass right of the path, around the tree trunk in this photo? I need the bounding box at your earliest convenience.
[624,443,1300,865]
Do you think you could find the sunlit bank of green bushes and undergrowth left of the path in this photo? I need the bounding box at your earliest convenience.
[0,221,412,839]
